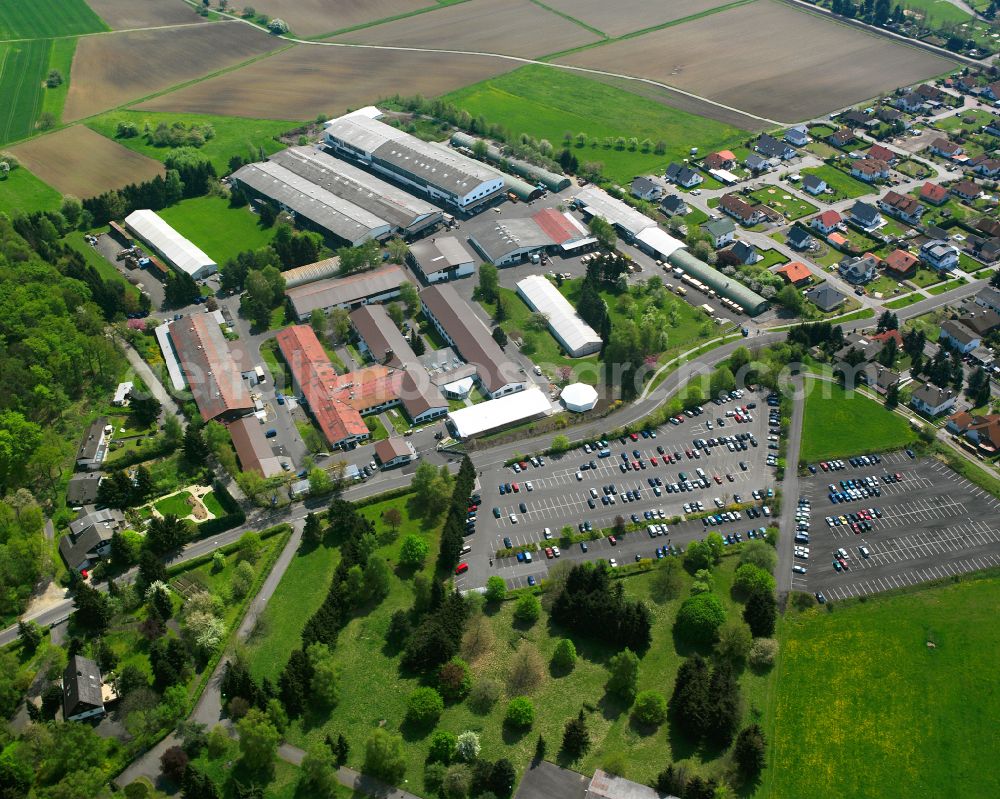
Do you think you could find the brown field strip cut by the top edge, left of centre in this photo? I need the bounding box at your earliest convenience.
[245,0,437,36]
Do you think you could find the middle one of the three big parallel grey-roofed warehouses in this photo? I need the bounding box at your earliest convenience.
[270,147,442,237]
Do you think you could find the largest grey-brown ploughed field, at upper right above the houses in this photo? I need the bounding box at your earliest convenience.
[560,0,955,122]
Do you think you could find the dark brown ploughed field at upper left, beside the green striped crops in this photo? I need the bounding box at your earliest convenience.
[63,22,284,121]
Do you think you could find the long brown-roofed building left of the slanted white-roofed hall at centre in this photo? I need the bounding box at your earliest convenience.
[420,283,525,399]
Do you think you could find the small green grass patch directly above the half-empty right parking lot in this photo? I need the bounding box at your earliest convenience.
[800,380,916,463]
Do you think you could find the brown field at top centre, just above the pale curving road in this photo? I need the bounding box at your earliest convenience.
[335,0,600,57]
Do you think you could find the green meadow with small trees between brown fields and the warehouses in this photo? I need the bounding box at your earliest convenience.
[86,111,300,175]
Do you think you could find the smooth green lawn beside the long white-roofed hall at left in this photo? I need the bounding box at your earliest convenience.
[158,197,274,264]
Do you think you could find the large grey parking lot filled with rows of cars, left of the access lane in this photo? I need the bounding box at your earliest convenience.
[458,392,777,587]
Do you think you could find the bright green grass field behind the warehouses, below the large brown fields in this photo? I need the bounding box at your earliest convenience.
[444,66,746,181]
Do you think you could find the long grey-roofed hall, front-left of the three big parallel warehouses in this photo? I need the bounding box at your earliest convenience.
[233,161,392,243]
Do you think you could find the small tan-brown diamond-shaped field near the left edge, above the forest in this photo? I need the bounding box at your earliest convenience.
[10,125,164,199]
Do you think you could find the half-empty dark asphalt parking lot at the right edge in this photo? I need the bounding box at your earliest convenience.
[792,452,1000,601]
